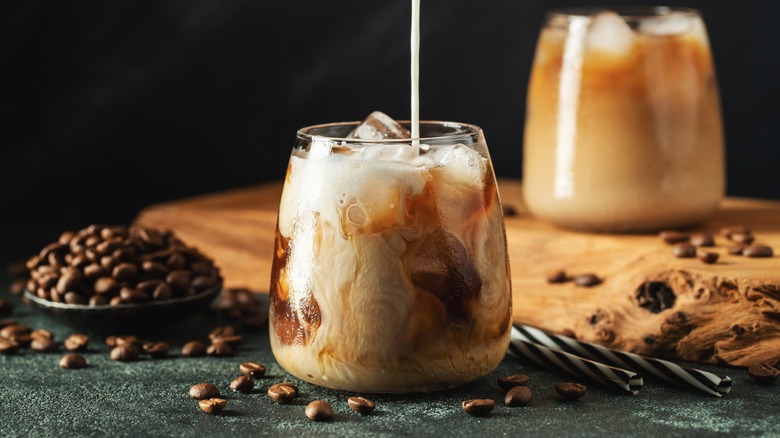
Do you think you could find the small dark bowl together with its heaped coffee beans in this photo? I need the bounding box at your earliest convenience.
[25,225,222,332]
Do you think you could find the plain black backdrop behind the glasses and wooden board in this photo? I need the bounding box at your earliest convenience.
[0,0,780,256]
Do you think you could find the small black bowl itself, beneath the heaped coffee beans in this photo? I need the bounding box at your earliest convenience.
[24,282,222,334]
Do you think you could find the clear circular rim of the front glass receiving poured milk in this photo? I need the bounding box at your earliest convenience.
[296,120,482,144]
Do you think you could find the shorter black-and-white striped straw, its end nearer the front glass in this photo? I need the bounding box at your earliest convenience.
[509,328,642,394]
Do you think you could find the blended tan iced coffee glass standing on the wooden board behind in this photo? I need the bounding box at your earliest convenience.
[523,8,724,231]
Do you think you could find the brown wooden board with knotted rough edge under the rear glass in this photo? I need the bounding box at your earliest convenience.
[136,180,780,366]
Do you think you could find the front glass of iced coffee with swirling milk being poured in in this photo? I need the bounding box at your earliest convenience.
[270,122,511,393]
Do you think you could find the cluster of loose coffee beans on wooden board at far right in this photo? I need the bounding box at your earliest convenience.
[658,225,774,264]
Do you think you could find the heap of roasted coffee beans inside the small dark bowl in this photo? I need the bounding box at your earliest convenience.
[26,225,222,305]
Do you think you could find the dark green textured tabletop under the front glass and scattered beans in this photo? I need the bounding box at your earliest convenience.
[0,278,780,437]
